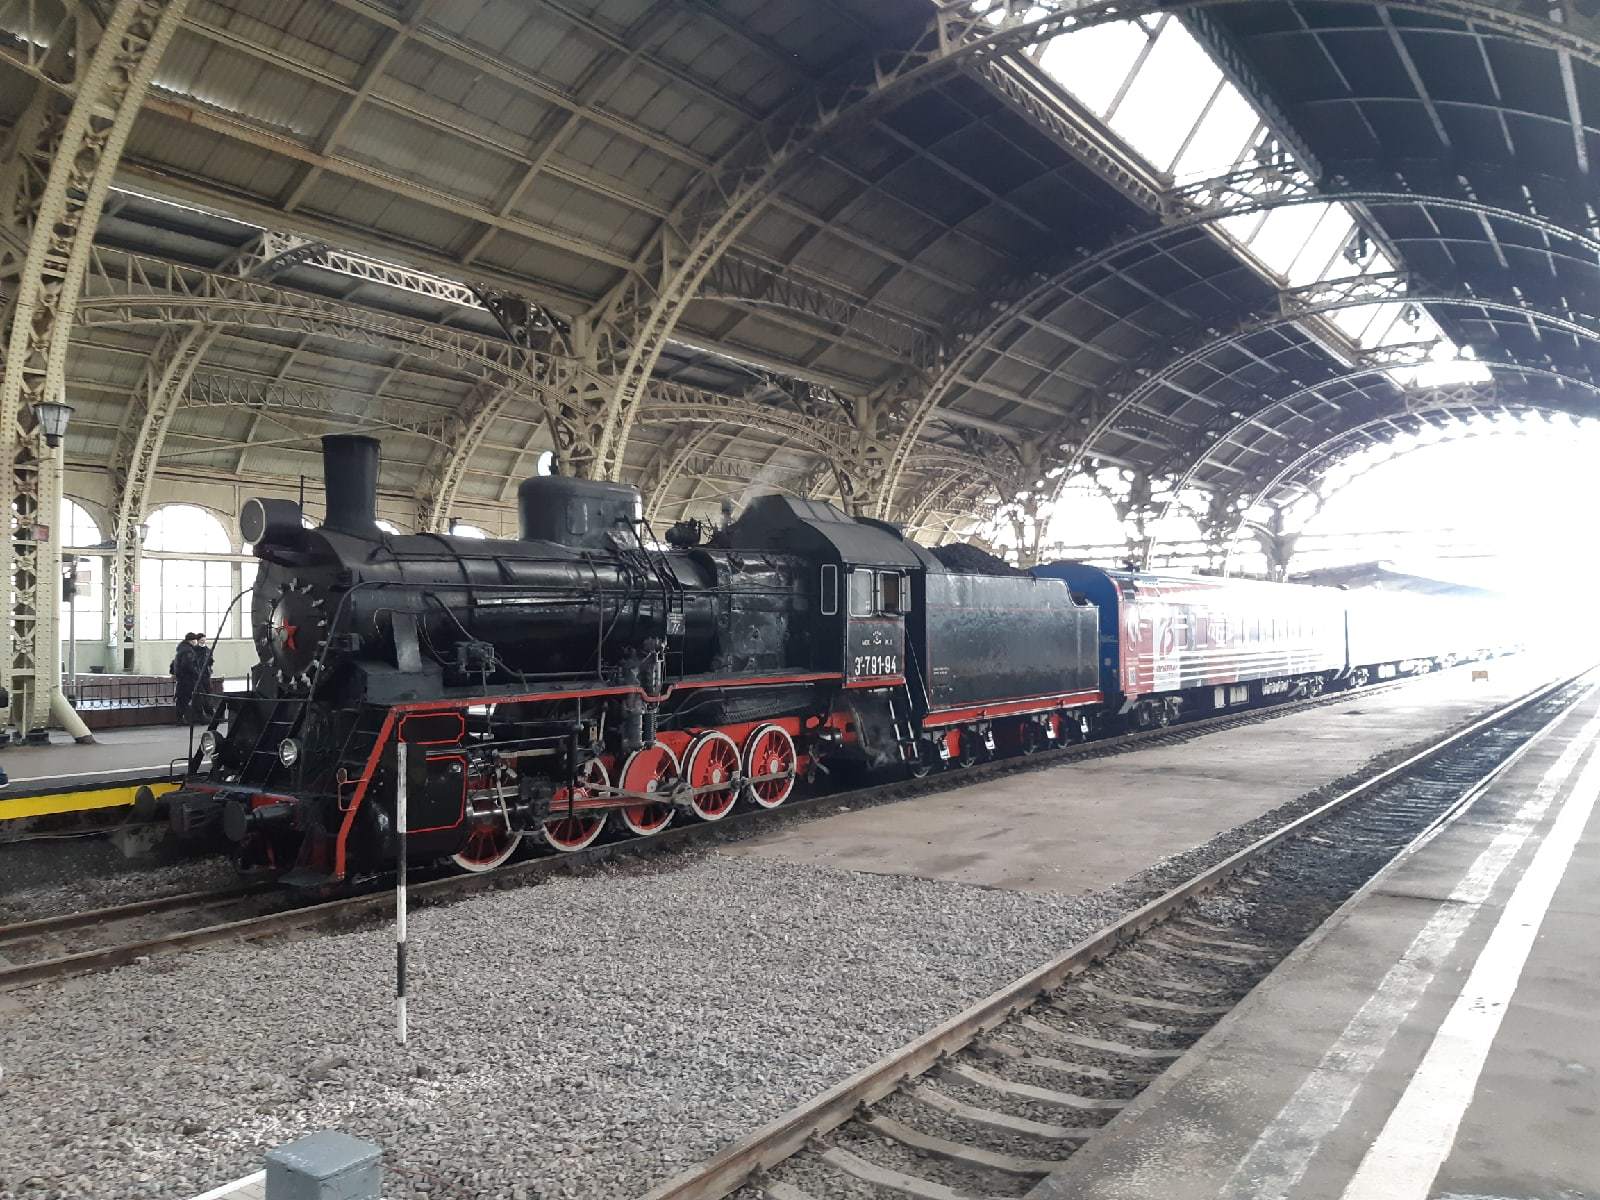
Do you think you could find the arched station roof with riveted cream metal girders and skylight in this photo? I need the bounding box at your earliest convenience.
[0,0,1600,723]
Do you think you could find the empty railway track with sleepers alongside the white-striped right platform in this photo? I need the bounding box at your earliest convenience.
[630,672,1594,1200]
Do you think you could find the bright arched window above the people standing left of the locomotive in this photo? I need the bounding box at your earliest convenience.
[139,504,238,642]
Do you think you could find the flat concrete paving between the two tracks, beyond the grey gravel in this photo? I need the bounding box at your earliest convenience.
[722,656,1565,893]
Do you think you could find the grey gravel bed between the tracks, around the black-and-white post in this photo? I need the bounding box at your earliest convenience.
[0,853,1115,1200]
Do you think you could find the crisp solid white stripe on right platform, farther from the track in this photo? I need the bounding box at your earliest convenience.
[1344,723,1600,1200]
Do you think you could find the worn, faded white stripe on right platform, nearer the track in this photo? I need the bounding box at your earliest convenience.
[1219,700,1600,1200]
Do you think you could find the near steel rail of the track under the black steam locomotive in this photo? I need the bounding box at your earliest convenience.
[0,662,1523,992]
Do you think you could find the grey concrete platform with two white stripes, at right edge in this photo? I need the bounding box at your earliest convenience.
[1029,672,1600,1200]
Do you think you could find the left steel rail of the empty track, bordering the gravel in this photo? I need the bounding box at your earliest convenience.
[627,667,1595,1200]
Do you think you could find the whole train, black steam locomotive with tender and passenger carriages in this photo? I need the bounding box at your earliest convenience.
[166,435,1504,886]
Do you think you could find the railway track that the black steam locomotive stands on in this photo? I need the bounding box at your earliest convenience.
[0,678,1523,992]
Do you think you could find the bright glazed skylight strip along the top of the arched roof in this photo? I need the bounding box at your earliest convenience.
[1029,10,1490,387]
